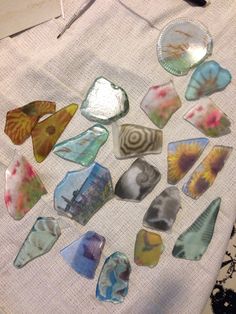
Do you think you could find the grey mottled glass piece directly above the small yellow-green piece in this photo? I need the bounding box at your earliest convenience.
[143,186,181,231]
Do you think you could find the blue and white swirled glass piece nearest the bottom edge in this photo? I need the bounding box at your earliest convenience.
[96,252,131,303]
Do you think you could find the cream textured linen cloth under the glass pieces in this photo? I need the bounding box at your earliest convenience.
[0,0,236,314]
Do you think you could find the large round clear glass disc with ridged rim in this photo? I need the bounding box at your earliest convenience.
[157,19,213,75]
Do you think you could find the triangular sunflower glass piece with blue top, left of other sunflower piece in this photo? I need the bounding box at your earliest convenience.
[167,138,209,184]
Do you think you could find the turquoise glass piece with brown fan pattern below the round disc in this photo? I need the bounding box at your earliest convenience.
[185,61,232,100]
